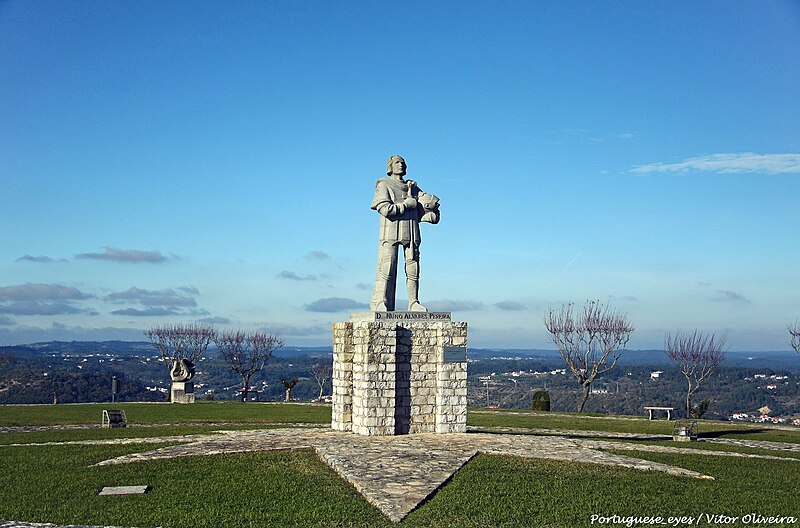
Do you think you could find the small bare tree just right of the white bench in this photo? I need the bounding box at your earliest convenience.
[665,330,725,418]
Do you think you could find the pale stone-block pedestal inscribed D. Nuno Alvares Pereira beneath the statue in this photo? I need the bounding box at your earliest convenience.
[331,312,467,435]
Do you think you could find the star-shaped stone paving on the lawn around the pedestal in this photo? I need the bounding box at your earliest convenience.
[84,428,798,522]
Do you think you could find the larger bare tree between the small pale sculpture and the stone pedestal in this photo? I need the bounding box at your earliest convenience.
[214,330,283,401]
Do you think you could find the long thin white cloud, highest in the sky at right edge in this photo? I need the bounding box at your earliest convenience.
[630,152,800,174]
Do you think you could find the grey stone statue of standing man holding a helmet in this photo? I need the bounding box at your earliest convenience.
[370,155,439,312]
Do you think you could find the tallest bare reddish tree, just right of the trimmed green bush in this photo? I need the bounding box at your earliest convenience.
[544,301,634,412]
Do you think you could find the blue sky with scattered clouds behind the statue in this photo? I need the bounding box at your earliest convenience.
[0,0,800,351]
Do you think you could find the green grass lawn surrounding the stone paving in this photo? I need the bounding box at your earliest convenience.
[0,403,800,528]
